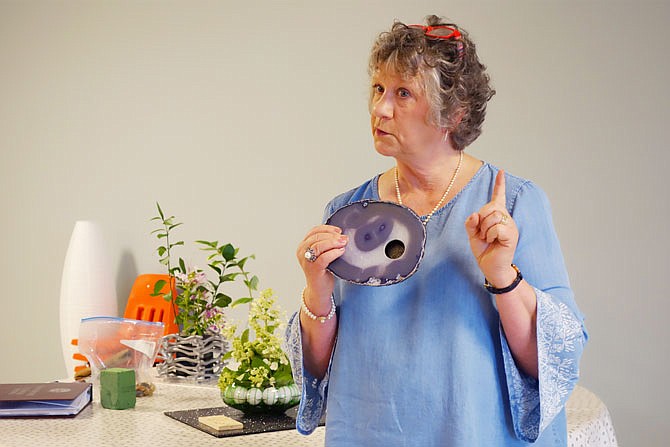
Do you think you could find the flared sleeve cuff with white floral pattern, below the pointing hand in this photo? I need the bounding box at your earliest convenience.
[500,289,586,442]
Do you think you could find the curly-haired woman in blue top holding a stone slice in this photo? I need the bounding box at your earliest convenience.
[288,16,586,447]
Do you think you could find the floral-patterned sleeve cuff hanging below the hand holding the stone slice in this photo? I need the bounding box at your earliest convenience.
[284,312,330,435]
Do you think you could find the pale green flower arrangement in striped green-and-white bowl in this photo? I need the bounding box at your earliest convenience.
[219,289,300,412]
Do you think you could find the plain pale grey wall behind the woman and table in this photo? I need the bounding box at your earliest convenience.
[0,0,670,446]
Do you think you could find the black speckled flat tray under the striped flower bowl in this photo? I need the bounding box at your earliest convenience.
[164,407,323,438]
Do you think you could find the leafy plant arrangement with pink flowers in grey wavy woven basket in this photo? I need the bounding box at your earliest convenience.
[151,203,258,380]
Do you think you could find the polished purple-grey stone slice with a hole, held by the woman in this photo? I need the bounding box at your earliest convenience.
[326,200,426,286]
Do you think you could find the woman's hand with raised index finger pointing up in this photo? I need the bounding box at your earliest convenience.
[465,170,519,288]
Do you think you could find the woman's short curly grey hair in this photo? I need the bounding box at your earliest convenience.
[368,15,495,150]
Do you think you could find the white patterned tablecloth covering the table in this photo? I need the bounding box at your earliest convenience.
[0,379,617,447]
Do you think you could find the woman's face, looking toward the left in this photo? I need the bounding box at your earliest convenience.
[370,70,444,158]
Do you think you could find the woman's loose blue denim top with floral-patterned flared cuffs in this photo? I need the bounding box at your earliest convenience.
[286,163,587,447]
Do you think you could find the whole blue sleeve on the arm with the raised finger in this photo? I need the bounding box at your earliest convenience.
[500,182,588,442]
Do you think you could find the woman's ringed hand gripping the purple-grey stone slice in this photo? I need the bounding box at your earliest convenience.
[296,225,349,302]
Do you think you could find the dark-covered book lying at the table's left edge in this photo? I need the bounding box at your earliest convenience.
[0,382,93,417]
